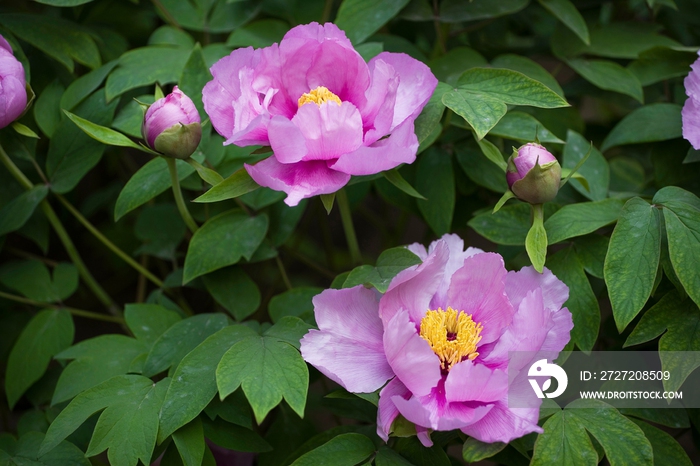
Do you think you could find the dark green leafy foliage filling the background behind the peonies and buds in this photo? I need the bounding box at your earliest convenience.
[0,0,700,466]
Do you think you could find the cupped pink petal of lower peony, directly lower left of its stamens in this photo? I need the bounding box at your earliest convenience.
[384,310,441,396]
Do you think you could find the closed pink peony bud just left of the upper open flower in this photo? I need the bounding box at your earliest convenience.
[141,86,202,159]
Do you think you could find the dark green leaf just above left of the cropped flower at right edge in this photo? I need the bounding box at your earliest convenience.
[627,47,698,86]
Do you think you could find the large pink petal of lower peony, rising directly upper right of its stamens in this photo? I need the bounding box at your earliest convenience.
[446,253,514,345]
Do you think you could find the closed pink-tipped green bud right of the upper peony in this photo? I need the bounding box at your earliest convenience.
[506,142,561,204]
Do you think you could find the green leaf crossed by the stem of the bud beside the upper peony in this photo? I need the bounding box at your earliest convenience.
[114,157,194,222]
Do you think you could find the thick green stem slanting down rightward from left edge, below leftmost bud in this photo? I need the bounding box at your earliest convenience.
[0,146,121,316]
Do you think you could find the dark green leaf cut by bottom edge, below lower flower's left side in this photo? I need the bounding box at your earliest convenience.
[292,433,374,466]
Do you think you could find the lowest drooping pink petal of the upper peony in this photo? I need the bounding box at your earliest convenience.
[245,156,350,207]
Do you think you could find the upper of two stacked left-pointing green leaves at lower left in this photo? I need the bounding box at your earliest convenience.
[51,335,148,405]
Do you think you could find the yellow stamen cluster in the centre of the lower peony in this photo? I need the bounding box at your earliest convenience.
[420,307,484,371]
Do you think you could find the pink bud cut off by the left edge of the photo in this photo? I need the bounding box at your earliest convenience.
[0,36,27,128]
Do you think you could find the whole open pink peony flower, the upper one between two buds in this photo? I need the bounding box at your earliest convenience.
[202,23,437,206]
